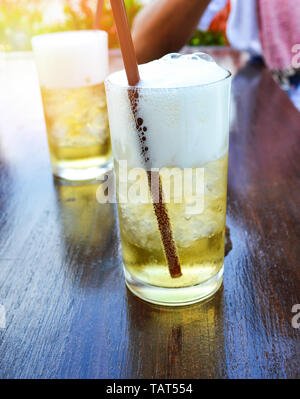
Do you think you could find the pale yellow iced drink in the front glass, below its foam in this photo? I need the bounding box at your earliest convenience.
[115,154,228,288]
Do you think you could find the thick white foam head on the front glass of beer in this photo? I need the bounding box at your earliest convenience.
[106,53,230,168]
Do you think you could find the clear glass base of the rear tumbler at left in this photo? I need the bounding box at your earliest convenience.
[53,160,113,182]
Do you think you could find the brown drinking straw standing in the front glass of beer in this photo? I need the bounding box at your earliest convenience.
[110,0,182,278]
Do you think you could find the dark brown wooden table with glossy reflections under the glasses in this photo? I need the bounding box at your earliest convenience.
[0,50,300,378]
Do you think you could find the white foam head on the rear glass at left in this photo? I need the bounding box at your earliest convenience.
[32,30,108,89]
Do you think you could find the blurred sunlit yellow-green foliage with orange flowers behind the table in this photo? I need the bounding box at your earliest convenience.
[0,0,228,52]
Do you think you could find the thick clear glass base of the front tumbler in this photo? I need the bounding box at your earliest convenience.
[124,265,224,306]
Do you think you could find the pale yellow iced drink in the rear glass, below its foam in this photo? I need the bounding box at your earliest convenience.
[41,83,111,170]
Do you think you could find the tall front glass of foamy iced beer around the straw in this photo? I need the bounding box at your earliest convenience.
[105,53,231,306]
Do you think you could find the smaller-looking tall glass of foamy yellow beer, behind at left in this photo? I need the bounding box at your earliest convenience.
[32,31,111,181]
